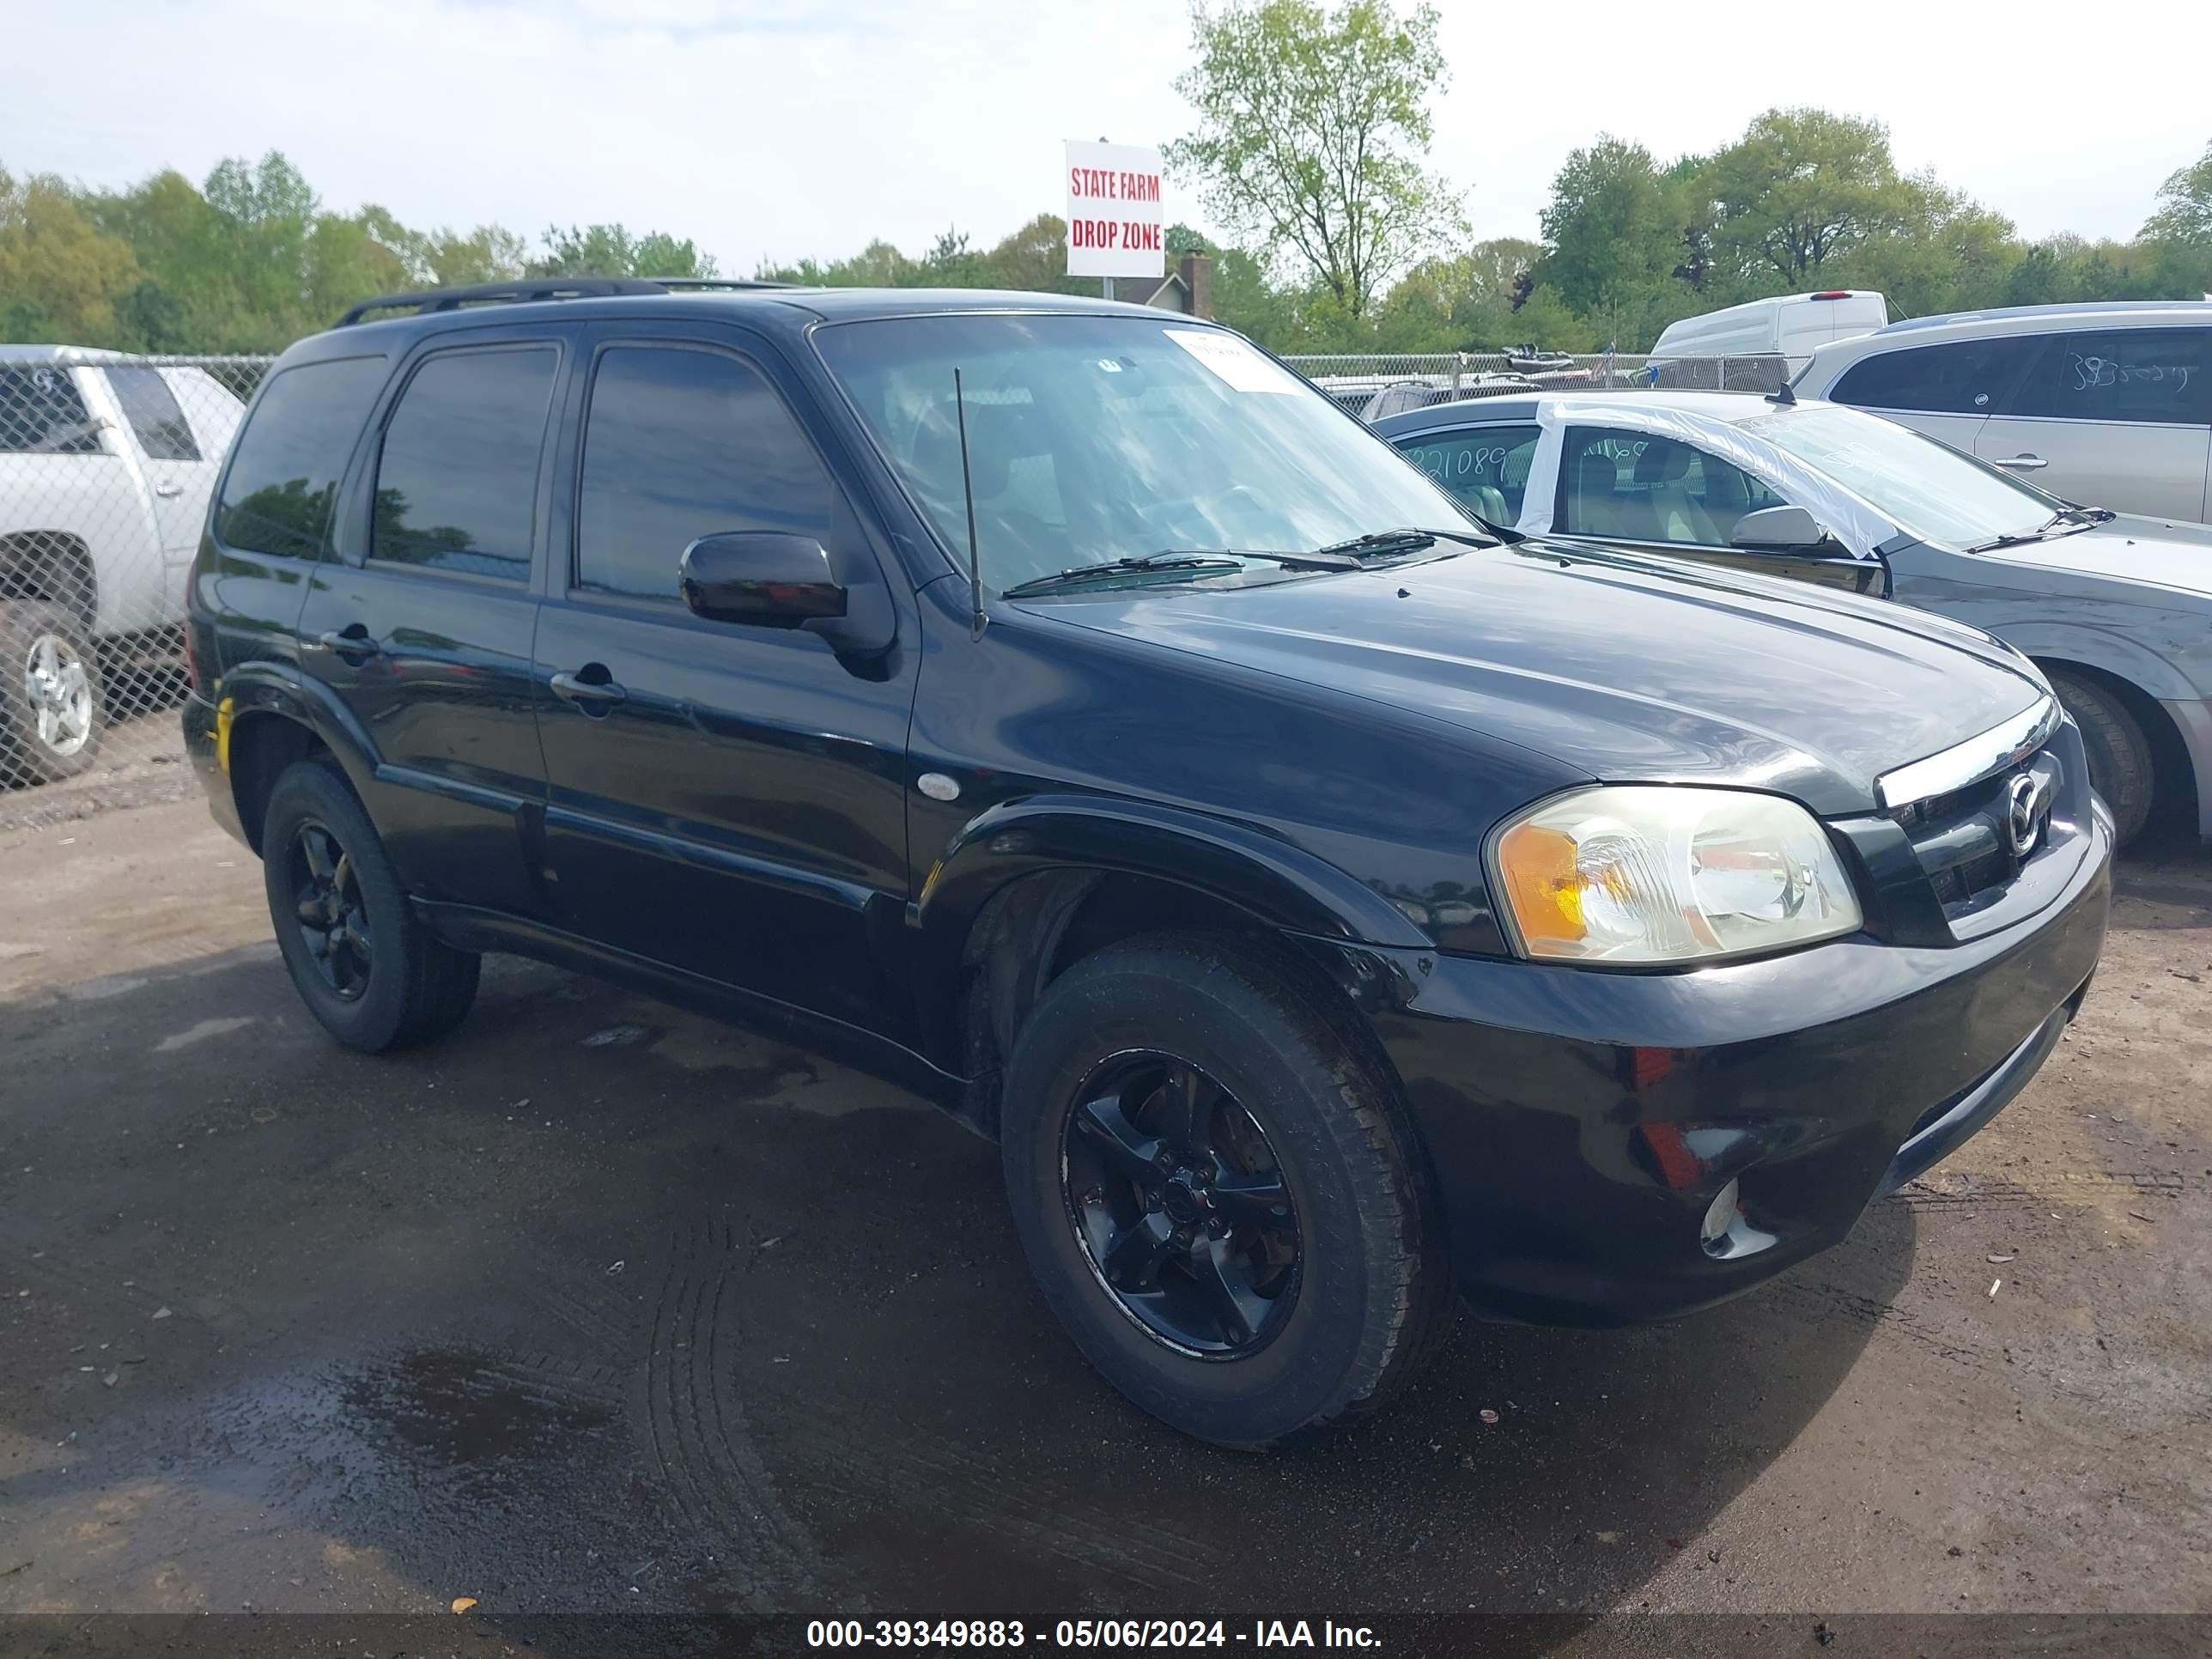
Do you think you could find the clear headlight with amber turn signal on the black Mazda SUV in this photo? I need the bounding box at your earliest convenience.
[1491,785,1860,967]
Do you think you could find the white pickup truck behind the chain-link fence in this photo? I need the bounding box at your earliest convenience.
[0,345,246,787]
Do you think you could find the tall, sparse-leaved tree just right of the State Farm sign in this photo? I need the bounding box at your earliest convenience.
[1168,0,1460,316]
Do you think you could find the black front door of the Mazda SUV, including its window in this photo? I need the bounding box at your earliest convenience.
[538,325,915,1036]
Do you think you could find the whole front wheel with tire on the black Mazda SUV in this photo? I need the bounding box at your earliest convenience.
[1002,936,1449,1449]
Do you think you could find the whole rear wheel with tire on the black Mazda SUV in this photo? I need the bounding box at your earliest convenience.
[261,761,484,1053]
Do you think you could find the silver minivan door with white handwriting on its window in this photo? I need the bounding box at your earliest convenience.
[1973,327,2212,520]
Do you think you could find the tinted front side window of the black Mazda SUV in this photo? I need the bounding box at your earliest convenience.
[575,345,838,599]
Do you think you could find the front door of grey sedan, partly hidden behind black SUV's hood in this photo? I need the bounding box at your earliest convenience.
[1558,427,1887,595]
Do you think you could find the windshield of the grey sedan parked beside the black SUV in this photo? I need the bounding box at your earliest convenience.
[1743,404,2063,546]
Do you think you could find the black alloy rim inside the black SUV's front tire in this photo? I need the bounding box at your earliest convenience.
[1060,1051,1301,1358]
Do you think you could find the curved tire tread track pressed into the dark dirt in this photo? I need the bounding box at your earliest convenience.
[641,1221,818,1613]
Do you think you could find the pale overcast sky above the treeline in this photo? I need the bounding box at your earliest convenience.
[0,0,2212,274]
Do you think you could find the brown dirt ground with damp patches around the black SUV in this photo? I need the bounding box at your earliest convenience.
[0,779,2212,1652]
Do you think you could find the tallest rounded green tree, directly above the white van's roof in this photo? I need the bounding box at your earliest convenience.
[1704,108,1916,292]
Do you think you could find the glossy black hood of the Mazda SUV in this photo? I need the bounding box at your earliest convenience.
[1037,542,2044,814]
